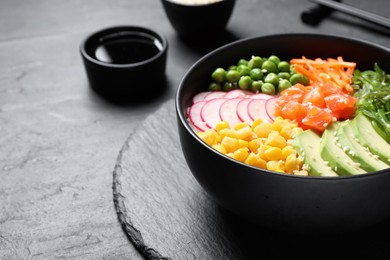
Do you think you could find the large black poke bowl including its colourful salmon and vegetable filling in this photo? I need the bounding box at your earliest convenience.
[175,34,390,234]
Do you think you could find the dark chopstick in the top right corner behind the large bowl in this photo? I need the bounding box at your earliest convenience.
[310,0,390,28]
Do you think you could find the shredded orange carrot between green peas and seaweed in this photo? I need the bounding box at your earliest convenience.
[290,56,356,93]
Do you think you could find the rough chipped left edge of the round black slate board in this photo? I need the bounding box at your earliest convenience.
[112,121,171,260]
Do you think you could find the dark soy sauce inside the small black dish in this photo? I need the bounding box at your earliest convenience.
[95,33,162,64]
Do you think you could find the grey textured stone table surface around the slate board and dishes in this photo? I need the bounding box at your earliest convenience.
[0,0,390,259]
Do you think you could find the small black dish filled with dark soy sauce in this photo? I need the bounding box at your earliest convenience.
[80,26,168,97]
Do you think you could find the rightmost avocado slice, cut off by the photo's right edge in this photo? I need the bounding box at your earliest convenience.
[352,114,390,164]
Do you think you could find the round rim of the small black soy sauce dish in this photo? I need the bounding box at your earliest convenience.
[80,25,168,69]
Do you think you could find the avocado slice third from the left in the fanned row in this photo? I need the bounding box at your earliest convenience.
[337,120,390,172]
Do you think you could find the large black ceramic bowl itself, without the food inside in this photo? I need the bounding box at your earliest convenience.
[175,34,390,233]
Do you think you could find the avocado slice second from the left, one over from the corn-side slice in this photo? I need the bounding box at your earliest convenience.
[320,122,367,175]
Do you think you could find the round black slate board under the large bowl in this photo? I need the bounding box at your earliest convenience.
[113,100,390,259]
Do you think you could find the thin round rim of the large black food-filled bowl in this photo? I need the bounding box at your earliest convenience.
[175,33,390,181]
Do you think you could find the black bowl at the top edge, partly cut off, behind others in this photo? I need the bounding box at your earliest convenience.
[161,0,235,38]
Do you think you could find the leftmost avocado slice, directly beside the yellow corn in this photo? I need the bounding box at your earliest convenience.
[293,130,338,176]
